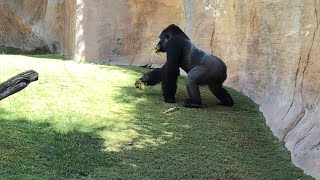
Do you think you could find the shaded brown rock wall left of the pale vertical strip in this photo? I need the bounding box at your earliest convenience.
[0,0,75,56]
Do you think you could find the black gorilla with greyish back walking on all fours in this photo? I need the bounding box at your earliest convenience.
[140,24,234,108]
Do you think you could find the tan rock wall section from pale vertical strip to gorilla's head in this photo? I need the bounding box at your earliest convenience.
[75,0,184,64]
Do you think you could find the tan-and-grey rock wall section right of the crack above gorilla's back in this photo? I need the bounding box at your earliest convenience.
[211,0,320,179]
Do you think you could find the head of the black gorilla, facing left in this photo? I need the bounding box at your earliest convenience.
[156,24,189,52]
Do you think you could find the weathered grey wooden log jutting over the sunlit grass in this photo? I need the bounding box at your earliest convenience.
[0,70,39,101]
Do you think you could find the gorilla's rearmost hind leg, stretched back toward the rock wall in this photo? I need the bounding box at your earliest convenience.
[209,83,234,106]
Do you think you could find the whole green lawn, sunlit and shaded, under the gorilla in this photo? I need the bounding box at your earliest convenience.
[0,56,312,180]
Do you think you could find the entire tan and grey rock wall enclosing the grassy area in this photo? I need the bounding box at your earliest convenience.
[0,0,320,179]
